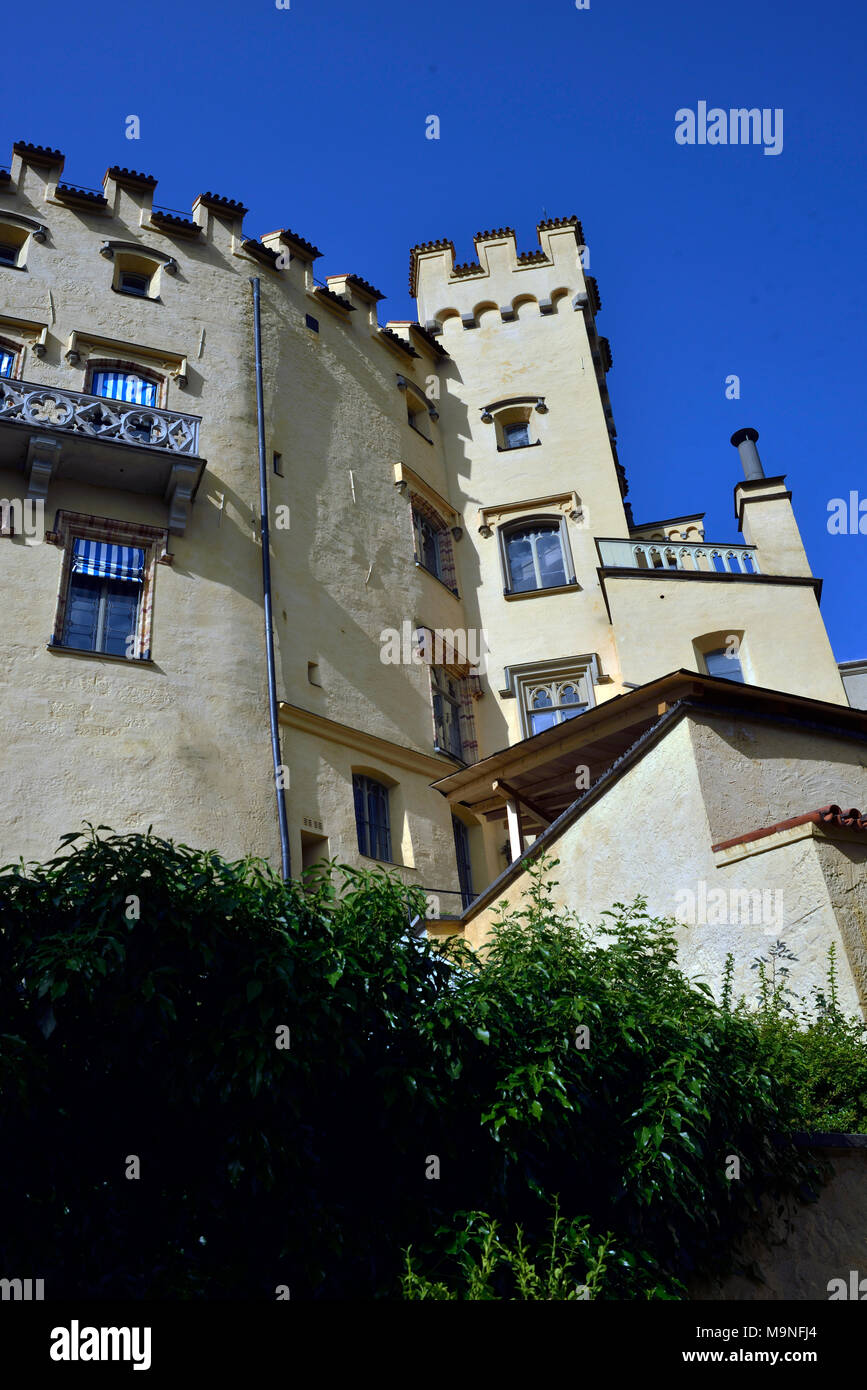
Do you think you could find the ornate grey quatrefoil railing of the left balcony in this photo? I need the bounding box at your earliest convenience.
[0,377,201,457]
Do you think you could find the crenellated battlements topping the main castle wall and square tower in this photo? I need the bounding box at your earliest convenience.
[0,140,591,378]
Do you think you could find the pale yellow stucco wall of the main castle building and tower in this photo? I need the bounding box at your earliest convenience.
[0,143,845,911]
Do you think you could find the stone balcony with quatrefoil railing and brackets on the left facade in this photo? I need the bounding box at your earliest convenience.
[0,378,206,535]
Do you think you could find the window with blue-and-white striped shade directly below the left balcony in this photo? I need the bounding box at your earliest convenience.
[61,537,145,657]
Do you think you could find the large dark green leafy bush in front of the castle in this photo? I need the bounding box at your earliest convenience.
[0,827,863,1298]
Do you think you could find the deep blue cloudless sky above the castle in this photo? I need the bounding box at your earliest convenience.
[6,0,867,660]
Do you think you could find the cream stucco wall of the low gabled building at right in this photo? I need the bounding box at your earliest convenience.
[465,716,867,1012]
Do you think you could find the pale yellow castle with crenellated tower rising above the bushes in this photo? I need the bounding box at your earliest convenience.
[0,142,867,1008]
